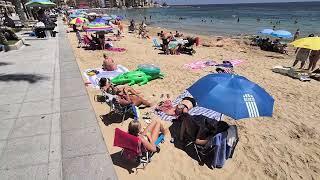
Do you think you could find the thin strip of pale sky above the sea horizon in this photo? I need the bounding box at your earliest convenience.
[166,0,320,4]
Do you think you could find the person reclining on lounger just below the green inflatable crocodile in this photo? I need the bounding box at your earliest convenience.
[99,78,151,107]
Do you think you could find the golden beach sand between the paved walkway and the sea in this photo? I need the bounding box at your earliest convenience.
[69,25,320,180]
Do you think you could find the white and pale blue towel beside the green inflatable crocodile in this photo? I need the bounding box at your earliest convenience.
[83,65,129,88]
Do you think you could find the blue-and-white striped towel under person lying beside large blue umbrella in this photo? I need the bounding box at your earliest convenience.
[155,90,222,121]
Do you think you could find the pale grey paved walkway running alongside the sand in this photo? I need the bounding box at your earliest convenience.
[0,22,117,180]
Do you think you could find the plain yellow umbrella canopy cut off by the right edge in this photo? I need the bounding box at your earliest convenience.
[291,37,320,50]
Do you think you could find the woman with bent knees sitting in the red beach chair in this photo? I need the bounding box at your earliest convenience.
[128,120,169,152]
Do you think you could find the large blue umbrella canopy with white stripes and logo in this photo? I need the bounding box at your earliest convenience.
[187,73,274,120]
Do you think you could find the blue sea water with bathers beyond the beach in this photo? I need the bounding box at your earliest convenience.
[106,2,320,36]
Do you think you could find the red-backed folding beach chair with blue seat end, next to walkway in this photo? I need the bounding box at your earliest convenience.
[113,128,164,169]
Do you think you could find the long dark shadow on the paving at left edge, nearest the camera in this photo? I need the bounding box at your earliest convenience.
[0,73,49,84]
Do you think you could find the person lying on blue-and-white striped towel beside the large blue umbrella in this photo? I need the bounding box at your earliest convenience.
[156,97,197,117]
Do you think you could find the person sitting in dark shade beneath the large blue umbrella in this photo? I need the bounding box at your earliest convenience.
[178,113,229,145]
